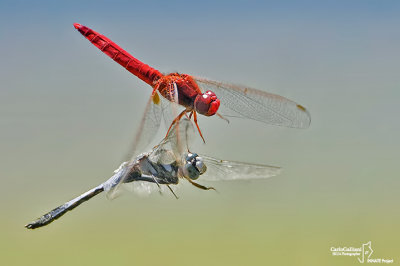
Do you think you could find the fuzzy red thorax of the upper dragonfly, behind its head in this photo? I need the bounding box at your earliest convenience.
[154,73,201,110]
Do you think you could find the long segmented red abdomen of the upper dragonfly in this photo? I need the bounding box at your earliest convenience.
[74,23,163,86]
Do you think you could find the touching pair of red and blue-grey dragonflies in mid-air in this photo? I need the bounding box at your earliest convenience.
[25,23,311,229]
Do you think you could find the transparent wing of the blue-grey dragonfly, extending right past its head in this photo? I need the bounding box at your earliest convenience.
[199,155,281,181]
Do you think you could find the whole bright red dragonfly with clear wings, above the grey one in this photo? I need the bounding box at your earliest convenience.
[74,23,311,148]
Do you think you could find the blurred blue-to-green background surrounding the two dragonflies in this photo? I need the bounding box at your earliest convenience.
[0,0,400,265]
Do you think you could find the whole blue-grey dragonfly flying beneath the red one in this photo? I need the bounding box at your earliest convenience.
[25,118,280,229]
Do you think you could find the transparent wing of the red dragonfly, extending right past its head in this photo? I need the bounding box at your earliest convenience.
[194,77,311,128]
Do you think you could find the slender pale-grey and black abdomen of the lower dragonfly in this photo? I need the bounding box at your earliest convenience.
[25,184,104,229]
